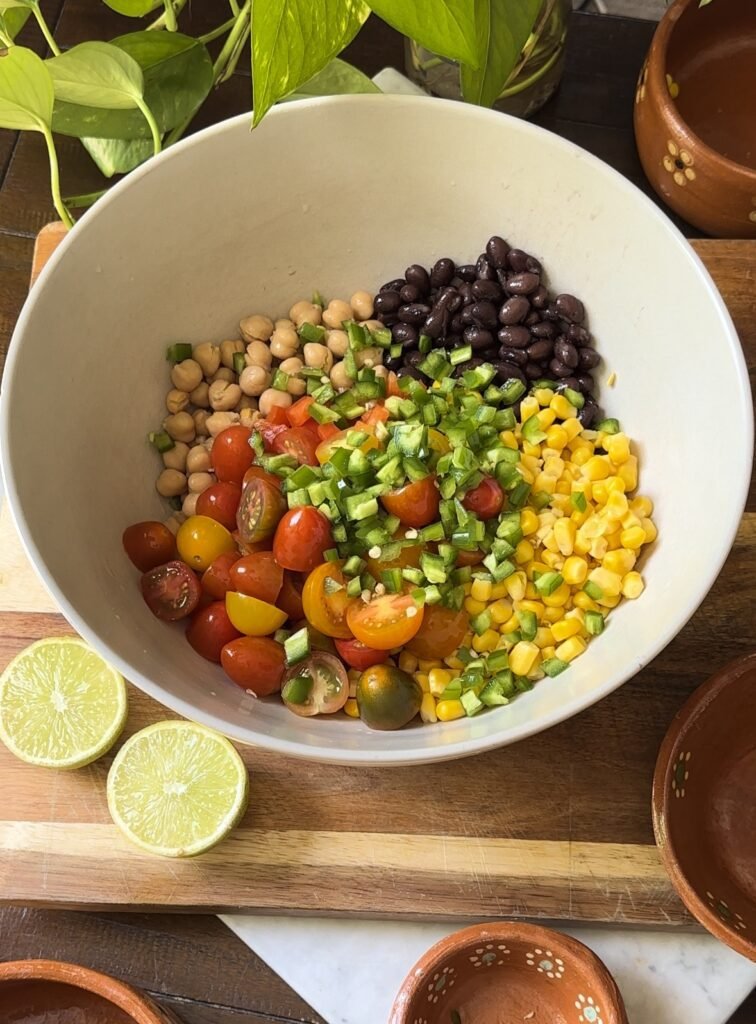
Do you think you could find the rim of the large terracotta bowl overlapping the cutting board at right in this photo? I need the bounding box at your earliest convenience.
[652,651,756,961]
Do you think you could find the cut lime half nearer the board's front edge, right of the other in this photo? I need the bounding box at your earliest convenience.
[108,721,249,857]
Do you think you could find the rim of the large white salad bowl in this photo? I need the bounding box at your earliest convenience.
[0,93,754,767]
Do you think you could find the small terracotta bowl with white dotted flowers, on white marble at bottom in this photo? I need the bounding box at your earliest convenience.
[389,922,627,1024]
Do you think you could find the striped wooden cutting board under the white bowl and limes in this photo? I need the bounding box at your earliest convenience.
[0,239,756,926]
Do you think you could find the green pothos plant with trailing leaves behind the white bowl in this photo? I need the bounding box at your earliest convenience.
[0,0,549,226]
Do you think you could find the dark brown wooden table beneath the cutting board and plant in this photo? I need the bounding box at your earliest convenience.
[0,8,756,1024]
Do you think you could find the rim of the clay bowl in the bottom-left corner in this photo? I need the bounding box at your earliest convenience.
[0,959,175,1024]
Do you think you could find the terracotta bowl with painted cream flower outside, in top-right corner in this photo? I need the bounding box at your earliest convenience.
[634,0,756,239]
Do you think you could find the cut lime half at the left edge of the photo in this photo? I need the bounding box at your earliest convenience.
[0,637,127,768]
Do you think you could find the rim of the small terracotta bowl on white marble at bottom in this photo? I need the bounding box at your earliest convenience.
[388,922,628,1024]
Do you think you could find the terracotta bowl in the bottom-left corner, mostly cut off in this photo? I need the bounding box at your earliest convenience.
[0,959,179,1024]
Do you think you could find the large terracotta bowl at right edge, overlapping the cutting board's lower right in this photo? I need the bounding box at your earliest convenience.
[654,653,756,961]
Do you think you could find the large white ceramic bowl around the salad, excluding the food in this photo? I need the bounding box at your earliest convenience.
[2,95,753,764]
